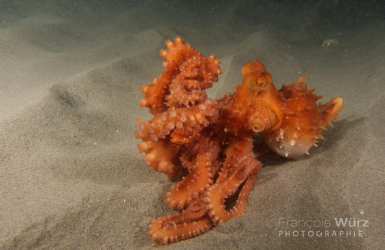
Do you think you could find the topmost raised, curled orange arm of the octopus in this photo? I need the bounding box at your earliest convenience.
[139,37,222,115]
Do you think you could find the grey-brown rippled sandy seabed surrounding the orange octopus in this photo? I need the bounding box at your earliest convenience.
[0,1,385,249]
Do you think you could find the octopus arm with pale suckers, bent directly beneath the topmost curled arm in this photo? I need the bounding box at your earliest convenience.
[135,99,218,177]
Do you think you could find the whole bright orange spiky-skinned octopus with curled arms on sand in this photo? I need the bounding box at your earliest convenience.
[135,37,343,244]
